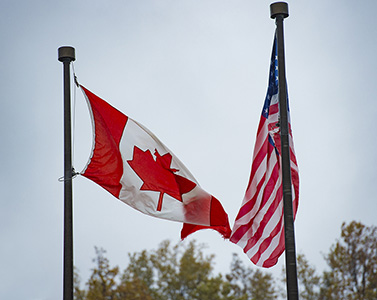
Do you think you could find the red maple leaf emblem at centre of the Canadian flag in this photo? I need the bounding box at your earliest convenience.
[127,146,196,211]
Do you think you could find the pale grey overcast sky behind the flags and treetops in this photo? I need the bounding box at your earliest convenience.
[0,0,377,300]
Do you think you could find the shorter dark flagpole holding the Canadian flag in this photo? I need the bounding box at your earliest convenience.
[58,47,75,300]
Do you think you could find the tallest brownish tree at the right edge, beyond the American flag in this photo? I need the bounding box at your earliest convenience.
[320,221,377,300]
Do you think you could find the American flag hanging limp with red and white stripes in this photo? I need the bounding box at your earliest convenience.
[230,35,299,268]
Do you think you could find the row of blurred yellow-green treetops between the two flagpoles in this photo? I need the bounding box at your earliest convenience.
[75,241,276,300]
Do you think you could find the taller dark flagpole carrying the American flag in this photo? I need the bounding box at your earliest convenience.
[270,2,298,300]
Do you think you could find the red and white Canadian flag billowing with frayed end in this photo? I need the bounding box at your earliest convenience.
[80,85,231,239]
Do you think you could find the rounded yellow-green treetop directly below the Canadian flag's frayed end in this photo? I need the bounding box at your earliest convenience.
[117,241,222,300]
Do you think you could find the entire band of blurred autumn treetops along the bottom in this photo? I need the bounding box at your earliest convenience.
[75,221,377,300]
